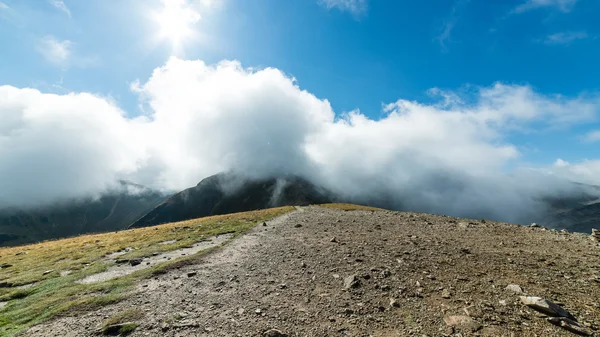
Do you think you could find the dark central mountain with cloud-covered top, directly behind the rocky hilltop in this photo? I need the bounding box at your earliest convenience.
[130,173,335,228]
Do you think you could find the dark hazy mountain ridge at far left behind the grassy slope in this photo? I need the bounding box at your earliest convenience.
[0,182,167,246]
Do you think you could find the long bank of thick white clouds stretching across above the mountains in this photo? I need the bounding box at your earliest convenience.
[0,58,600,222]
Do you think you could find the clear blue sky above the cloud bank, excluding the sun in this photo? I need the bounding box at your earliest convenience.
[0,0,600,109]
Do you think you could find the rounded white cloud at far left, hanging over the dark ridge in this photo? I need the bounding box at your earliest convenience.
[0,86,142,206]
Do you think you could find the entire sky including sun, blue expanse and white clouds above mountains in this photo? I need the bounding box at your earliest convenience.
[0,0,600,223]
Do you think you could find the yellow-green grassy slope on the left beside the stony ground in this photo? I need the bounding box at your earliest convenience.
[0,207,293,336]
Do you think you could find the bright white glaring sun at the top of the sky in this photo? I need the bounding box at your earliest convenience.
[154,0,200,46]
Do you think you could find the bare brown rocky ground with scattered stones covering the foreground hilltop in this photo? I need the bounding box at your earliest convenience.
[23,206,600,336]
